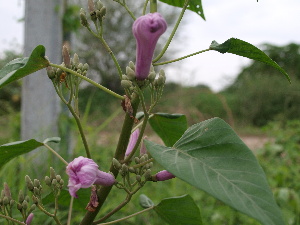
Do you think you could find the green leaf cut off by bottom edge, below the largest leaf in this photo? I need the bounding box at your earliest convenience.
[154,195,202,225]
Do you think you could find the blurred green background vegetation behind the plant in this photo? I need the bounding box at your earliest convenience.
[0,1,300,225]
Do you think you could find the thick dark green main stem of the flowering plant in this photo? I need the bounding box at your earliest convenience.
[80,95,139,225]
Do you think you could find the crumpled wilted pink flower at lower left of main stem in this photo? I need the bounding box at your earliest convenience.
[66,156,115,198]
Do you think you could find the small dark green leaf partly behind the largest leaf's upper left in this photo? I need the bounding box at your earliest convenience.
[149,113,187,146]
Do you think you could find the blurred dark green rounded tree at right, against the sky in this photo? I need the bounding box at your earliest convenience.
[224,43,300,126]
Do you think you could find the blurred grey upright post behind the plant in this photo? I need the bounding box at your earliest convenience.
[21,0,62,139]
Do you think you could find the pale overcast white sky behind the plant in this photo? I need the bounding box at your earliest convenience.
[0,0,300,91]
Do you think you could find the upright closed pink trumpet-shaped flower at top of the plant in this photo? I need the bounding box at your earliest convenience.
[132,13,167,80]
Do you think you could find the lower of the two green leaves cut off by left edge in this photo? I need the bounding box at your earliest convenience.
[0,139,43,169]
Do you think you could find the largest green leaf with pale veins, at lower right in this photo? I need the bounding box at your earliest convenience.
[145,118,284,225]
